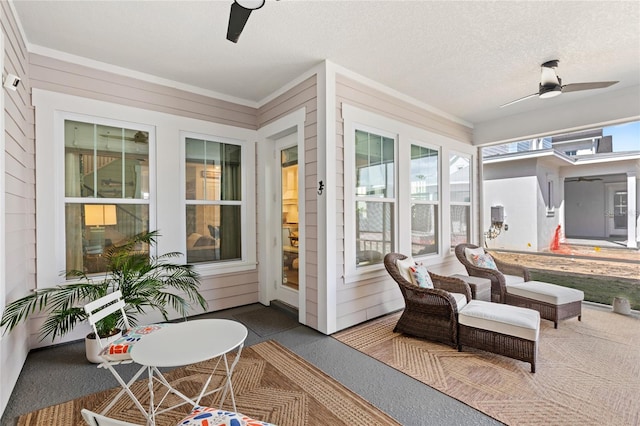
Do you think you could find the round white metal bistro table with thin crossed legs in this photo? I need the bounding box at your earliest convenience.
[131,319,247,425]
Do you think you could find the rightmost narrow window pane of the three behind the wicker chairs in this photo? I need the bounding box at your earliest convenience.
[449,154,471,248]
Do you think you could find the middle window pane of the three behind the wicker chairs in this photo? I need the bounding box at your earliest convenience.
[410,145,440,256]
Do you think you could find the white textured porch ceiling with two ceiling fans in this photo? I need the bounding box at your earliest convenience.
[12,0,640,124]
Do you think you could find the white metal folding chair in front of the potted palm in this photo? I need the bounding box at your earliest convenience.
[84,290,166,425]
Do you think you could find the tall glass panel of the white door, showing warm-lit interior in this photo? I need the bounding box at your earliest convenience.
[280,146,300,290]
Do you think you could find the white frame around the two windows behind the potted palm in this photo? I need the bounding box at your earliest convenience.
[32,88,257,288]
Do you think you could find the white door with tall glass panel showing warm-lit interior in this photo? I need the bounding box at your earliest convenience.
[272,133,303,308]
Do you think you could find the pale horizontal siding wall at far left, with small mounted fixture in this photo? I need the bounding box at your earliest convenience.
[0,1,36,412]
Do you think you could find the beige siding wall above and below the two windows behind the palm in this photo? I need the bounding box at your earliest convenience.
[30,60,258,338]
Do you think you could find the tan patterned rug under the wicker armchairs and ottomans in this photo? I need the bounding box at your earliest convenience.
[333,305,640,425]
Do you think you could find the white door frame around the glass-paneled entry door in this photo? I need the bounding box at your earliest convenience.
[256,107,306,324]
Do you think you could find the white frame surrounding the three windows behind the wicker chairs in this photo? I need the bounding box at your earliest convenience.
[342,104,477,284]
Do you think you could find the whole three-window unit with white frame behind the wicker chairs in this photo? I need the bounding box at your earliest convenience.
[338,104,477,284]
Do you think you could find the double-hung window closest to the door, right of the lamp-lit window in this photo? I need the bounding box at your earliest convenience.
[185,137,243,263]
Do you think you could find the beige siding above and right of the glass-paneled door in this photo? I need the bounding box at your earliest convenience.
[257,75,318,329]
